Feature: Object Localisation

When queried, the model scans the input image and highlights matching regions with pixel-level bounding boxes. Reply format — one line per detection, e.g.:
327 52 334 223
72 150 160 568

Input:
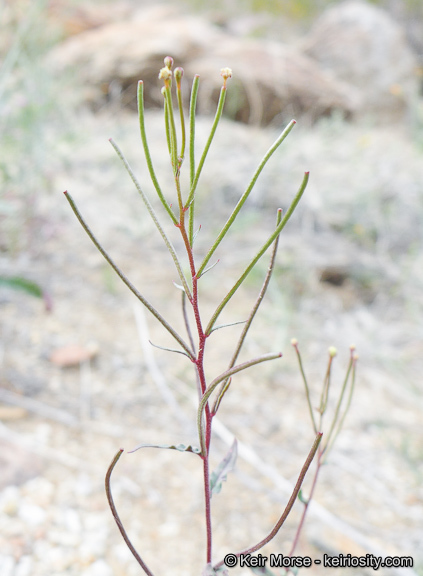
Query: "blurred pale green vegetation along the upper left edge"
0 0 66 254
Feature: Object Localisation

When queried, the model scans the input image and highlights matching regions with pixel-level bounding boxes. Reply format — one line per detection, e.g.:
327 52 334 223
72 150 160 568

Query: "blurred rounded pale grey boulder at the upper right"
303 0 418 120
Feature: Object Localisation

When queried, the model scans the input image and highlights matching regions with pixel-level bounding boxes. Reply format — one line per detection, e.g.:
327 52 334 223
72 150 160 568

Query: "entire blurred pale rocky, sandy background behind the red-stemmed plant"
0 0 423 576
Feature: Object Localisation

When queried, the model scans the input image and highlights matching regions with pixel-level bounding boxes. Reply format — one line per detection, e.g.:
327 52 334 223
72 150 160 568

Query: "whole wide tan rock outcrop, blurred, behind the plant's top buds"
49 5 359 124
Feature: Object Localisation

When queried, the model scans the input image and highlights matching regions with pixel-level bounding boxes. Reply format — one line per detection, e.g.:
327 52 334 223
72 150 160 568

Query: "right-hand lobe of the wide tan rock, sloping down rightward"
186 38 360 125
